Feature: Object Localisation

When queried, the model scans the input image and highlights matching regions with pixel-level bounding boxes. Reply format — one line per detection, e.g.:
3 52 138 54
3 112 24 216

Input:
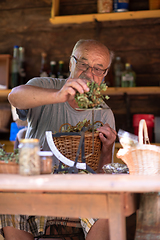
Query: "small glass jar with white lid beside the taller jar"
38 151 53 174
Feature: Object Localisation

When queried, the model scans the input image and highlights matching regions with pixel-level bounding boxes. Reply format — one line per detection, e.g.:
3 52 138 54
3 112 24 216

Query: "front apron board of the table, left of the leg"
0 192 108 218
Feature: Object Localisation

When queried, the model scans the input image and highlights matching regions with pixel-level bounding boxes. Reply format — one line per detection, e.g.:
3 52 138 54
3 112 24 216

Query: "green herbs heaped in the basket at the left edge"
0 144 19 163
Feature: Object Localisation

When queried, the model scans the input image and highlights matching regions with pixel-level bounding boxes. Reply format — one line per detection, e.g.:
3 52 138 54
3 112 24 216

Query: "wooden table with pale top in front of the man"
0 174 160 240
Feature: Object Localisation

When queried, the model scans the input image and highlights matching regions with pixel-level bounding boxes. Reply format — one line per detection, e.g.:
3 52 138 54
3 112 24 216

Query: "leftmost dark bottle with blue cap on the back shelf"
10 45 19 88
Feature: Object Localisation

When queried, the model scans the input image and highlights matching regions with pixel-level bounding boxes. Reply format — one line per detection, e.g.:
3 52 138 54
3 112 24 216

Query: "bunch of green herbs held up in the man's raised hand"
75 82 109 109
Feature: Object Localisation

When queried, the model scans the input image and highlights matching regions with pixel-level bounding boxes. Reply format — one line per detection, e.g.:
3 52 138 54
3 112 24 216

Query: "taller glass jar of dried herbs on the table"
19 138 40 175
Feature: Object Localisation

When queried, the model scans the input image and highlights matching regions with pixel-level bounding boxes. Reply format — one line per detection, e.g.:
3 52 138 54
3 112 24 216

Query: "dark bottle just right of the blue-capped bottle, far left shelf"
19 47 26 85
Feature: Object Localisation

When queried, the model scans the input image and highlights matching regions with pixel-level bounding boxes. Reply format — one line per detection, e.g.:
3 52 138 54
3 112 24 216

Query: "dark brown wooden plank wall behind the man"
0 0 160 137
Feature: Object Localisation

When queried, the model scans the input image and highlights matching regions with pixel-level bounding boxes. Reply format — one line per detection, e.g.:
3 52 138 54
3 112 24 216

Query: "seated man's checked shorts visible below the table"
0 215 97 237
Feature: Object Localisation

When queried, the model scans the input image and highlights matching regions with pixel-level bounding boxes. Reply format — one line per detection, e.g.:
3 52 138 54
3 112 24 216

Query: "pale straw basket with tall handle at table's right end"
117 119 160 175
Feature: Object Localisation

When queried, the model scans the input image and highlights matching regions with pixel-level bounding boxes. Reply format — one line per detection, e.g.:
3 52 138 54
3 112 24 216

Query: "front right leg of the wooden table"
108 193 126 240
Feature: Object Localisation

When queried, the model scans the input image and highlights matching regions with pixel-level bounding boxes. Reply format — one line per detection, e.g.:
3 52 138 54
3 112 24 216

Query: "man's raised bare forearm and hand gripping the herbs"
8 79 89 109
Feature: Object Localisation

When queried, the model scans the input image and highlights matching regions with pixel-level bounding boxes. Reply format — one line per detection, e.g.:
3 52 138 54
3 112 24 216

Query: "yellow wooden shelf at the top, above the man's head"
50 0 160 24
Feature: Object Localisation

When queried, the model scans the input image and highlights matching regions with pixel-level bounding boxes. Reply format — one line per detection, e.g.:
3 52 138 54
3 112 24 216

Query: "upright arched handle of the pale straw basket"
138 119 150 144
